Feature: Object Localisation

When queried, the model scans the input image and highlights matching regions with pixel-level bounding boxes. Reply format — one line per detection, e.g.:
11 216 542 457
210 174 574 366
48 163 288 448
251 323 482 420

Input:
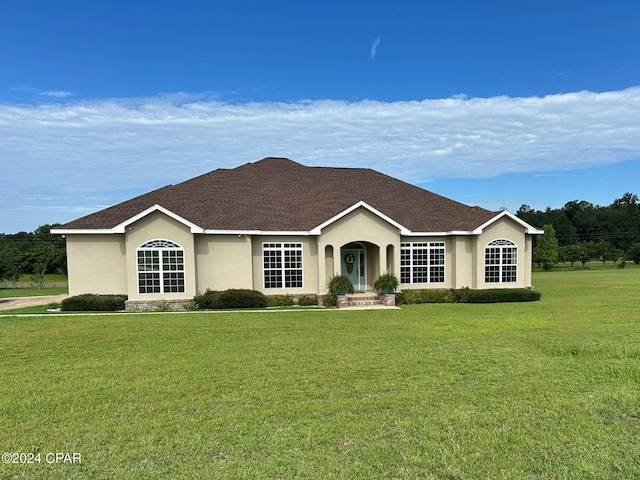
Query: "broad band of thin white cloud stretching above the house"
0 87 640 231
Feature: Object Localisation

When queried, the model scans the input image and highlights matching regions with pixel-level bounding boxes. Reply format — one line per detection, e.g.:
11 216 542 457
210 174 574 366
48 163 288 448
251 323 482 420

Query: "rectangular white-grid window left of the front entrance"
262 243 302 288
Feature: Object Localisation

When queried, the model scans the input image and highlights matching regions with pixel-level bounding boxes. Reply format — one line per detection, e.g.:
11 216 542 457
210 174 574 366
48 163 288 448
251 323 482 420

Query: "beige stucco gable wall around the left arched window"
125 212 197 300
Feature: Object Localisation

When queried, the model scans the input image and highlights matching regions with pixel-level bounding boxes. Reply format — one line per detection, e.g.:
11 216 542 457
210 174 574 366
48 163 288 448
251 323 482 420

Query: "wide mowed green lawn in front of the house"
0 267 640 479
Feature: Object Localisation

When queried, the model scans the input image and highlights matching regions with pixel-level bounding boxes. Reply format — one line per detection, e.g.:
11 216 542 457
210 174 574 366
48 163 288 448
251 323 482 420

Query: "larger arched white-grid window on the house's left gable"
137 240 185 293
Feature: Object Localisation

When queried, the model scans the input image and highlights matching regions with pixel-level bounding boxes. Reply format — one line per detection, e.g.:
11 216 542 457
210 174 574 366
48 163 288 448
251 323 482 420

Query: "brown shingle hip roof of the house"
58 157 497 232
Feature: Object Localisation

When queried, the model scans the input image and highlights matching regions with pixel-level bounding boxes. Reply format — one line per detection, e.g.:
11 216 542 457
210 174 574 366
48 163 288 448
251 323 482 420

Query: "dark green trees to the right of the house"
516 193 640 266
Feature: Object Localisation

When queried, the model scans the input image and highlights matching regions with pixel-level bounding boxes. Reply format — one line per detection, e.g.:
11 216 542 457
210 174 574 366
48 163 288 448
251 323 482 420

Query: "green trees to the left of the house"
0 224 67 286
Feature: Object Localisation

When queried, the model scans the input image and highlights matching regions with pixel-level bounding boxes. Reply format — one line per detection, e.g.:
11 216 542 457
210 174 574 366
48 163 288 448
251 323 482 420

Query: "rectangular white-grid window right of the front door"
400 242 445 283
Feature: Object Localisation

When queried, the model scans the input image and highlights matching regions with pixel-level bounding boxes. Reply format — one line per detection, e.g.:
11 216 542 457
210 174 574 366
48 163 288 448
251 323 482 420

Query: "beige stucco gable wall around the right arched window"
470 217 532 289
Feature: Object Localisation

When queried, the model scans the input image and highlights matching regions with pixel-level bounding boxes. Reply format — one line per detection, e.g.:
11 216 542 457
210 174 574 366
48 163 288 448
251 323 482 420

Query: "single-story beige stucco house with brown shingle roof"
52 158 542 302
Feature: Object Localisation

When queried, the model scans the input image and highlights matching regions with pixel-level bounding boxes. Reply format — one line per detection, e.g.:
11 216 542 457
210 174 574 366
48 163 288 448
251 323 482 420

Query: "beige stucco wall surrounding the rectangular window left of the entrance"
249 235 318 295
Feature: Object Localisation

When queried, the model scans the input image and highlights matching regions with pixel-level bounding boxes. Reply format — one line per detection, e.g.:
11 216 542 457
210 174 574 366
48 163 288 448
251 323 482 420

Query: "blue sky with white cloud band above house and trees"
0 0 640 233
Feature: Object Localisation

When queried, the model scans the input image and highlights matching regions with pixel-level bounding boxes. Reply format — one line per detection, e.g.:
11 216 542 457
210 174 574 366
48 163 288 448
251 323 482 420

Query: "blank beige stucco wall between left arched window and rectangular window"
195 235 254 292
